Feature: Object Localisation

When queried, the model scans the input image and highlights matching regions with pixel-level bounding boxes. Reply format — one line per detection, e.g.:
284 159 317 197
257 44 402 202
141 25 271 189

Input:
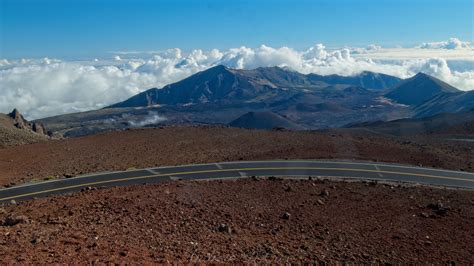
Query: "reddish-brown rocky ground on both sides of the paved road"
0 123 474 264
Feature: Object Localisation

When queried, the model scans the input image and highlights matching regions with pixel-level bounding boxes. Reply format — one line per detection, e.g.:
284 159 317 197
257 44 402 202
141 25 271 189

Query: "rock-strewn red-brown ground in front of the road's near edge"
0 178 474 265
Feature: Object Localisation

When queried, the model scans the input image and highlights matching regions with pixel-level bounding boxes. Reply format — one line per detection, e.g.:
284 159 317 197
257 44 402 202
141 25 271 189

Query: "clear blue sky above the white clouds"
0 0 474 59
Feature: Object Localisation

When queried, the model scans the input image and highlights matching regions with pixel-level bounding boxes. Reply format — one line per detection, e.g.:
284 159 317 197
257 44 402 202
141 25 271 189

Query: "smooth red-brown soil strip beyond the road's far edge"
0 126 474 186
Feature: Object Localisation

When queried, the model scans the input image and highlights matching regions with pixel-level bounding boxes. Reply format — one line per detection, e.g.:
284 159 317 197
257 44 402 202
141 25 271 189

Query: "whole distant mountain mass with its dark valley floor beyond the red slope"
35 65 468 136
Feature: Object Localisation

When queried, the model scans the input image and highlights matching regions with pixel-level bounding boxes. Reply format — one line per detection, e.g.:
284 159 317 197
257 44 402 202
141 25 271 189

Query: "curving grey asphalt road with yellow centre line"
0 160 474 203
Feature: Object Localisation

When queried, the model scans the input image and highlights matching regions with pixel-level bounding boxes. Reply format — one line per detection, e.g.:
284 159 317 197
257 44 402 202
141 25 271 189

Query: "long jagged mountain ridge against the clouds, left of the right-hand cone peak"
106 65 401 108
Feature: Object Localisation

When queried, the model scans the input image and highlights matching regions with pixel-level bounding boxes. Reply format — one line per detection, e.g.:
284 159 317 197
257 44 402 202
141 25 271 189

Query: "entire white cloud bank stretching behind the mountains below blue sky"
0 38 474 119
